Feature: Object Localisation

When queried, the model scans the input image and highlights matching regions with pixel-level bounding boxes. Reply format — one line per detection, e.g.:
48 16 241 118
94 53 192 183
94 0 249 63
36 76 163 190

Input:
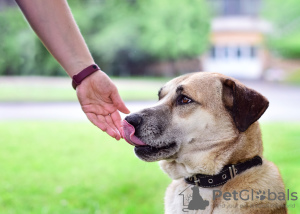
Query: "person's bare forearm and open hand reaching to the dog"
16 0 129 140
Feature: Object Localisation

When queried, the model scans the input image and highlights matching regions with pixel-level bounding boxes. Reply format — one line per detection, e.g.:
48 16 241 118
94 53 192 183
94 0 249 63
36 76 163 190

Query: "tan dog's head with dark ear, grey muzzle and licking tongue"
123 72 268 176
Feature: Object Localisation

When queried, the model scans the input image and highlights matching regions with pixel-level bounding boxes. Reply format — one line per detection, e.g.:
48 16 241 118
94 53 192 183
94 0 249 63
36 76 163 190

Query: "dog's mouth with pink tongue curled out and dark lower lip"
122 120 176 160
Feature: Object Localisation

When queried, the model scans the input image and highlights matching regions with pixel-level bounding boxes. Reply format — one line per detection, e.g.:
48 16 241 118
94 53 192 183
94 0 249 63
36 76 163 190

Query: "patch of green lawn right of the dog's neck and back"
262 123 300 214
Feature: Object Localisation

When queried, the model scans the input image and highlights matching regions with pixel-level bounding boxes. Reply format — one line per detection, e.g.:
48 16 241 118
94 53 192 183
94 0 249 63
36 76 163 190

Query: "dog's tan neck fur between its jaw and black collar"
160 122 263 180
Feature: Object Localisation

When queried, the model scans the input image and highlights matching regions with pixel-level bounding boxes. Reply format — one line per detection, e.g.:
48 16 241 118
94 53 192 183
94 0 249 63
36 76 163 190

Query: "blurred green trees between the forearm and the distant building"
81 0 209 75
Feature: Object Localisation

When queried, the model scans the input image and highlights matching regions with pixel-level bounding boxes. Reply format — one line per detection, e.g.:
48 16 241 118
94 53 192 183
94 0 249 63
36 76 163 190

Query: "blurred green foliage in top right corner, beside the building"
264 0 300 58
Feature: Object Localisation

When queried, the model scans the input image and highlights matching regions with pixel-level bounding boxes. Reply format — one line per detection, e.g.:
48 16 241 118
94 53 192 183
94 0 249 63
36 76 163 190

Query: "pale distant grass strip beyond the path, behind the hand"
0 77 169 102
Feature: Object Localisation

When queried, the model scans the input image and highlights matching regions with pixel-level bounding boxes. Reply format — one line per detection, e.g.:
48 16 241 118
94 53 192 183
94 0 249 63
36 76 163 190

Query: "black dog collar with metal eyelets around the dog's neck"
184 156 262 187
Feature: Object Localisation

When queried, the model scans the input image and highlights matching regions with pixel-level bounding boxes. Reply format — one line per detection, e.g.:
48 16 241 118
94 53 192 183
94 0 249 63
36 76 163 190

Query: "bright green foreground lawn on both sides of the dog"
0 122 300 214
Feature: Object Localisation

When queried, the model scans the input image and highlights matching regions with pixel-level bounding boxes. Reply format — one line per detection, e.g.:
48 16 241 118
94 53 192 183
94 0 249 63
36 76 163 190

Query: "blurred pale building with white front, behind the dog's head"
202 0 270 79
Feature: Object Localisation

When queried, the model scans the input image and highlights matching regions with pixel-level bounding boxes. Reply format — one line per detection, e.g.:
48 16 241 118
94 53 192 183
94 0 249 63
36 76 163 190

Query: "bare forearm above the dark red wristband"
16 0 94 77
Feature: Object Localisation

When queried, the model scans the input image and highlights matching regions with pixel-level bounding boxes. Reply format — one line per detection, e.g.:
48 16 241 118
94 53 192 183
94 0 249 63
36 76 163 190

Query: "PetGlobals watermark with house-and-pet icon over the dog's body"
179 185 298 212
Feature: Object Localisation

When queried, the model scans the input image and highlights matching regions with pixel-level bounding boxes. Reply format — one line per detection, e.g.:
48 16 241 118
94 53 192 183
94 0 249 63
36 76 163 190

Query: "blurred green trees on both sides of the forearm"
0 0 209 75
